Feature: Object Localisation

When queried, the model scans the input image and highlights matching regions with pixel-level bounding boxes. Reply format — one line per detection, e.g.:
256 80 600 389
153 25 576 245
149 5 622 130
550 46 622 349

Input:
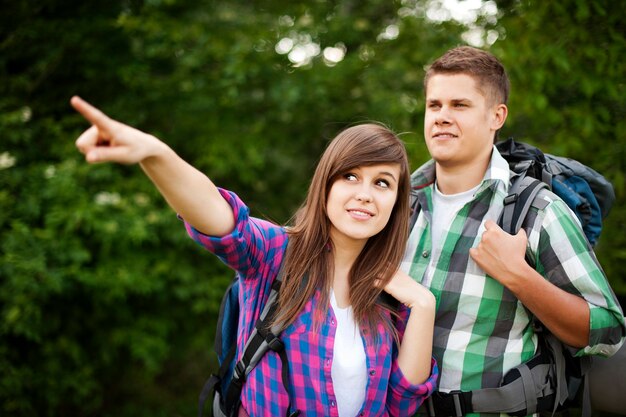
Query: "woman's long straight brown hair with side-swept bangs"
274 124 410 334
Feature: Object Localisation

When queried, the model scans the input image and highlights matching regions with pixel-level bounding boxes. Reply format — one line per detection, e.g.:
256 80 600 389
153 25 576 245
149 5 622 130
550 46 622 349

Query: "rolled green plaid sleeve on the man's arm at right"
529 193 626 356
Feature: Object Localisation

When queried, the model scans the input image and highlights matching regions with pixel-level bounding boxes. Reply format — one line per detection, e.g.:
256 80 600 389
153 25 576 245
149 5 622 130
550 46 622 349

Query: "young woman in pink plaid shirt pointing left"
71 97 437 417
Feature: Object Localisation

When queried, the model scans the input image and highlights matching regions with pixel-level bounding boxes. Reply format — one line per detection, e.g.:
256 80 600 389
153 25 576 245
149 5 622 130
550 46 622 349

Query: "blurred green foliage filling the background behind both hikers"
0 0 626 416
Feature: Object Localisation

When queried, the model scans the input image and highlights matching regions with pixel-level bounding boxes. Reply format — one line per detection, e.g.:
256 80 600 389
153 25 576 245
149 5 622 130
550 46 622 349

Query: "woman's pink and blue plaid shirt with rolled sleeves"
186 189 438 417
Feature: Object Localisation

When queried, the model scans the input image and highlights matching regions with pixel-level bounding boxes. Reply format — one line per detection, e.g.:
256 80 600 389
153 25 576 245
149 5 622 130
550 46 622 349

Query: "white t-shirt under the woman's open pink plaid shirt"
330 291 367 417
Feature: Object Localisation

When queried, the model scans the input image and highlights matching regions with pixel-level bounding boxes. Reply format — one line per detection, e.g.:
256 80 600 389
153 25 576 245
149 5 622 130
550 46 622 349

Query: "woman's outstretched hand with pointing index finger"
70 96 167 164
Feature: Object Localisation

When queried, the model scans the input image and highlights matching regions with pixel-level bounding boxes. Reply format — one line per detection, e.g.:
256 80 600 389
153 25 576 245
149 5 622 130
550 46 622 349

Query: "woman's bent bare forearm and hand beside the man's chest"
385 271 436 384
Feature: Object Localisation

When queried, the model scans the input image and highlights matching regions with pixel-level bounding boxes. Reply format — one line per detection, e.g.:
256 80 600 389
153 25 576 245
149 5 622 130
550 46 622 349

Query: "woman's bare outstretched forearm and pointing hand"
71 96 235 236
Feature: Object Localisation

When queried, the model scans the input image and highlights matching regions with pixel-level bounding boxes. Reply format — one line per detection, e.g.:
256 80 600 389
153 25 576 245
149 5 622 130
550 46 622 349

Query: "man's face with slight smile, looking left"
424 74 506 170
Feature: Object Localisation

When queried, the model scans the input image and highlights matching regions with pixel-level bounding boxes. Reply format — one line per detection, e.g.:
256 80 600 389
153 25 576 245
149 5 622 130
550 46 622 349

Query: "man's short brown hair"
424 46 509 104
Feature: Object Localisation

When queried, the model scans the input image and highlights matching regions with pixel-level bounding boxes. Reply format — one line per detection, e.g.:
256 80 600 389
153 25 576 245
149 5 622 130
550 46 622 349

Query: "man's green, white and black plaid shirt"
402 147 626 412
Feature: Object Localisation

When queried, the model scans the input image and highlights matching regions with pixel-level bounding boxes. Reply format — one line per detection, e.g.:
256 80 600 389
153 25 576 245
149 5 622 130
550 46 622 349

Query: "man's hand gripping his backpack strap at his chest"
469 220 528 288
